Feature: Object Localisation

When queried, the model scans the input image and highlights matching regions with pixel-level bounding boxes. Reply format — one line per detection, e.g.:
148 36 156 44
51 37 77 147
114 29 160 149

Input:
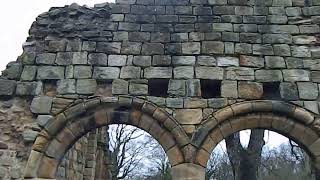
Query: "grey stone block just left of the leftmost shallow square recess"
16 82 42 96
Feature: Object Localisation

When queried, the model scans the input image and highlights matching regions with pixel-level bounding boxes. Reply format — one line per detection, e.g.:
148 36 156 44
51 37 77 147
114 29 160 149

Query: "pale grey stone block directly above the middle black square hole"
195 67 224 80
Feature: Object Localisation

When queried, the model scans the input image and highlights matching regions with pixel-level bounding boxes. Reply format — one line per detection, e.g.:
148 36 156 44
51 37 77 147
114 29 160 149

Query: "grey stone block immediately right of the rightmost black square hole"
279 82 299 101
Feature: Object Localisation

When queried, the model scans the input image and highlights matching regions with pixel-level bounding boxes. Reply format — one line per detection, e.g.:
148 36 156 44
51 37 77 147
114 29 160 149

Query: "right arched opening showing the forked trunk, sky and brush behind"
206 129 316 180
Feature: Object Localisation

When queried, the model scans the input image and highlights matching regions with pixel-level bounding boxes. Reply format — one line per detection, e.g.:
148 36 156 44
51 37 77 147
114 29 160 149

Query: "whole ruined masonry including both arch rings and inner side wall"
0 0 320 180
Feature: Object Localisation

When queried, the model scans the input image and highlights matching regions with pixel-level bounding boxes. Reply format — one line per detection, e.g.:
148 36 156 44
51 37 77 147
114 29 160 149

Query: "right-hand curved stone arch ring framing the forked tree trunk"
192 101 320 171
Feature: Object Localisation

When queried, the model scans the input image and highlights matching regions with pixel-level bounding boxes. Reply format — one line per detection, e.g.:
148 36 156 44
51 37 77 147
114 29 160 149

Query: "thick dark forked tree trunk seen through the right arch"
226 129 265 180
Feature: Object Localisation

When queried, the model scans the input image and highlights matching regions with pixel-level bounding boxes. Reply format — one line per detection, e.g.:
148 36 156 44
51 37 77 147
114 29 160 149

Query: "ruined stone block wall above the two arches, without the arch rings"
0 0 320 177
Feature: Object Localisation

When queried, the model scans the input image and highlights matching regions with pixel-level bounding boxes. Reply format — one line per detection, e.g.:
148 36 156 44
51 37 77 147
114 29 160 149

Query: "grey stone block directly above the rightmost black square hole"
255 70 283 82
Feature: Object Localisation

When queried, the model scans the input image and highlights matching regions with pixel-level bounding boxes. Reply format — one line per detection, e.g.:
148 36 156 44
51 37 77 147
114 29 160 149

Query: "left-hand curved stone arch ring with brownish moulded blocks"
25 97 189 179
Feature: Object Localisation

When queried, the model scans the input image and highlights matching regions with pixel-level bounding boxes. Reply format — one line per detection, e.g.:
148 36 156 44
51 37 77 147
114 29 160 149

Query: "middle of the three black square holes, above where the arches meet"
200 80 221 99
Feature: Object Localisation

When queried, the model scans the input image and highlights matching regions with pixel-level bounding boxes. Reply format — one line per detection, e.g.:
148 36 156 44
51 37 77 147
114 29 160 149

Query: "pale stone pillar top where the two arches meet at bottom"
172 163 206 180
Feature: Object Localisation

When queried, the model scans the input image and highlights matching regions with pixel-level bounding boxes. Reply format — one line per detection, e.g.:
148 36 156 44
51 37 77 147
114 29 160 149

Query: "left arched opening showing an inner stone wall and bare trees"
57 124 171 180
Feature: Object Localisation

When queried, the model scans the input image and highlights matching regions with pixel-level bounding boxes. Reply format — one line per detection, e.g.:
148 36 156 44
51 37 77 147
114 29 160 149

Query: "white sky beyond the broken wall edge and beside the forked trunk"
0 0 285 146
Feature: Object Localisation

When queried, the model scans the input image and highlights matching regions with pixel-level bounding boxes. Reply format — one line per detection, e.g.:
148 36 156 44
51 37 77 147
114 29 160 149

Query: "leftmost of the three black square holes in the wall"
149 79 169 97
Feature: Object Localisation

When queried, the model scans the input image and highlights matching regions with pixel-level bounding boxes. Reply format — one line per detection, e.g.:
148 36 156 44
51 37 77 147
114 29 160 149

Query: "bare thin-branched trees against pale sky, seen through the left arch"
109 125 171 180
